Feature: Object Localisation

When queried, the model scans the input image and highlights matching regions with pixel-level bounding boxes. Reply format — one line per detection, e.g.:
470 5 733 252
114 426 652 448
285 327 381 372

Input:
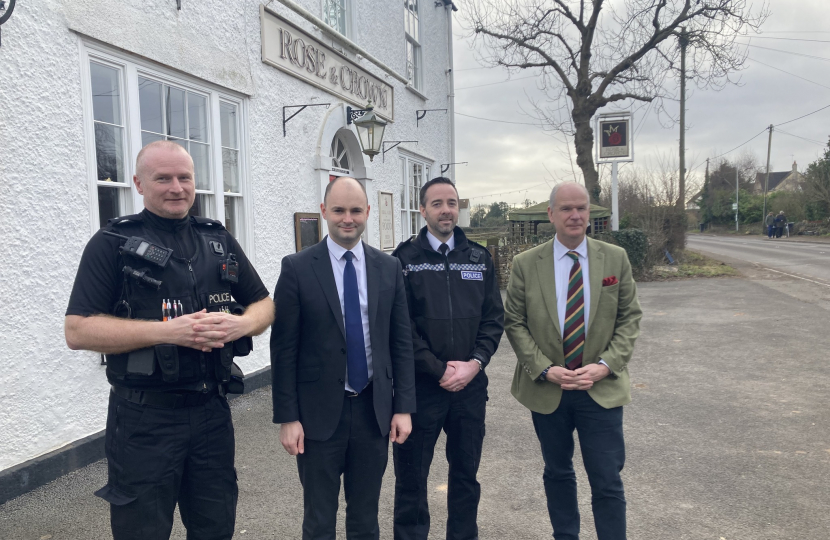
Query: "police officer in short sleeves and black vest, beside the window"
65 141 274 540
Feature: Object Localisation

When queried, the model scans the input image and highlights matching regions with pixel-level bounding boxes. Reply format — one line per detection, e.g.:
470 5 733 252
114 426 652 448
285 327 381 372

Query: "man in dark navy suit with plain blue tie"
271 177 415 540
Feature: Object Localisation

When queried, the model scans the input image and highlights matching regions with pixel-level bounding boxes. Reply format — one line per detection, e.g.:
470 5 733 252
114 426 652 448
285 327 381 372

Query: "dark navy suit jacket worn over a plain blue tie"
271 238 415 441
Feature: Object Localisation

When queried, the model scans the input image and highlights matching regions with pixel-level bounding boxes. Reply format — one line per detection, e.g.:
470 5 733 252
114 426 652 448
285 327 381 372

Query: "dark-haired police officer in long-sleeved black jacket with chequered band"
393 177 504 540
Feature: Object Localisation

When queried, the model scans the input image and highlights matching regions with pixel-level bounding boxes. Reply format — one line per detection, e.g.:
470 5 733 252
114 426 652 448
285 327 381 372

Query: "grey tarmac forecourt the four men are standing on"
0 273 830 540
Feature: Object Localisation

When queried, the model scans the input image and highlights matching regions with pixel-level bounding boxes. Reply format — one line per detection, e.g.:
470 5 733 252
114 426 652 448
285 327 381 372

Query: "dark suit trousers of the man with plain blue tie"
298 385 389 540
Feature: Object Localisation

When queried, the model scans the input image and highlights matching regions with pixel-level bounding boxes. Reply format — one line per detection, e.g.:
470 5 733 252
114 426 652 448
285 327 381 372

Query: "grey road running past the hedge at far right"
688 234 830 286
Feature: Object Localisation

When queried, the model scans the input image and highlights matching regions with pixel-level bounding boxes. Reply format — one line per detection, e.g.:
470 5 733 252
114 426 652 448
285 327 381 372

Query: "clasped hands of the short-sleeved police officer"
163 309 248 352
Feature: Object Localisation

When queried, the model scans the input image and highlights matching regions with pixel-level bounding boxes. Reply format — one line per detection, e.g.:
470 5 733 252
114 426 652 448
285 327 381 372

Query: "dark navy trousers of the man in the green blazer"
532 390 625 540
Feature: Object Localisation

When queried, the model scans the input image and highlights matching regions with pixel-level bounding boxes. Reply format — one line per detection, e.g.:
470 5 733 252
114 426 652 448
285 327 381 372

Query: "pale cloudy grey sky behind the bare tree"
453 0 830 208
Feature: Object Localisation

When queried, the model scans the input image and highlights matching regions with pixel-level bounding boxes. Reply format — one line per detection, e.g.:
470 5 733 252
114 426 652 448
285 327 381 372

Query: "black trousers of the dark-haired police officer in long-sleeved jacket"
393 371 487 540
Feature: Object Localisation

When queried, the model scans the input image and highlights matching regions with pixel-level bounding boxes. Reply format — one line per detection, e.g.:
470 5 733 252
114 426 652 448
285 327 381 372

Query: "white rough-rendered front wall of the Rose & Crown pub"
0 0 450 470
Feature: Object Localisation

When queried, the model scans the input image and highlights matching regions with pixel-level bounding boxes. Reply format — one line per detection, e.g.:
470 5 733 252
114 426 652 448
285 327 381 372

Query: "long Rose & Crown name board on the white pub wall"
259 6 395 122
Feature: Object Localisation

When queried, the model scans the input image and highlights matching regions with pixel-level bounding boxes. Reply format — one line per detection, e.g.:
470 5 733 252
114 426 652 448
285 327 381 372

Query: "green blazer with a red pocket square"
504 238 643 414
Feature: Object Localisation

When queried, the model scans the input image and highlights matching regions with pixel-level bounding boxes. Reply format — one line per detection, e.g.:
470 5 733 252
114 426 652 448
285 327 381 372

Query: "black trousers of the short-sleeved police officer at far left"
95 393 238 540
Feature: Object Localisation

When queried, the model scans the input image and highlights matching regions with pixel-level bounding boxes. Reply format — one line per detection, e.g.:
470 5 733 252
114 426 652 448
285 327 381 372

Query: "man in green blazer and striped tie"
504 183 642 540
